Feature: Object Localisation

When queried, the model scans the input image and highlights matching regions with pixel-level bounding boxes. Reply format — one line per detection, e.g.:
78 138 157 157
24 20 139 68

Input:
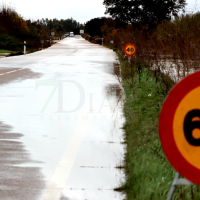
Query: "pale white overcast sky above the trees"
0 0 200 23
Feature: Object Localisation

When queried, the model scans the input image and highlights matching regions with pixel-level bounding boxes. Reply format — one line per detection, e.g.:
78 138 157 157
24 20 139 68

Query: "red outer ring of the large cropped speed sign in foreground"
159 71 200 185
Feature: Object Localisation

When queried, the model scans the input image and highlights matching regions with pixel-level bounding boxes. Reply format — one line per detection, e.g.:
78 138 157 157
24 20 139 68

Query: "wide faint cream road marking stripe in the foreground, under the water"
41 120 88 200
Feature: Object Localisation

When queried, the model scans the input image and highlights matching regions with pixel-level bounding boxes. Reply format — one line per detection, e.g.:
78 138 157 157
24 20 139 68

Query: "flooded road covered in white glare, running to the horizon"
0 36 124 200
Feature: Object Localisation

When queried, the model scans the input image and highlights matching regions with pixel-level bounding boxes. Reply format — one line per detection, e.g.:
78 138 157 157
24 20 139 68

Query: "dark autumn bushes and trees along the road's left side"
0 3 84 52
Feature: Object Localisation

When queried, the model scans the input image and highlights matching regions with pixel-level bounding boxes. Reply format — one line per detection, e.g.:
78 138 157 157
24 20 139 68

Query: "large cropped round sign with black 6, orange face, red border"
159 72 200 185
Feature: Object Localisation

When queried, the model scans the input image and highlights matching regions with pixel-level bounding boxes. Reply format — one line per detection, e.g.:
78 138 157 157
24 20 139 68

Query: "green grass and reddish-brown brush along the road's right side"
83 1 200 200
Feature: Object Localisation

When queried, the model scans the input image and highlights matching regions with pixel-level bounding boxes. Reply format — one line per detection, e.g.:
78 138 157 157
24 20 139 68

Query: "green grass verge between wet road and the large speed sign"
116 51 200 200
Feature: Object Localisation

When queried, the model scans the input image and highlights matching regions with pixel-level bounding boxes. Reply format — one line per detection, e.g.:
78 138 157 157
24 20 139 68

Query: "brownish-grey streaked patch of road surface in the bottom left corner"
0 122 45 200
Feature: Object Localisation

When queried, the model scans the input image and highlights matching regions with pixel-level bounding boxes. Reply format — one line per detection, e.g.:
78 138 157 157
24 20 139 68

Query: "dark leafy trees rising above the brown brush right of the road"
85 0 186 37
